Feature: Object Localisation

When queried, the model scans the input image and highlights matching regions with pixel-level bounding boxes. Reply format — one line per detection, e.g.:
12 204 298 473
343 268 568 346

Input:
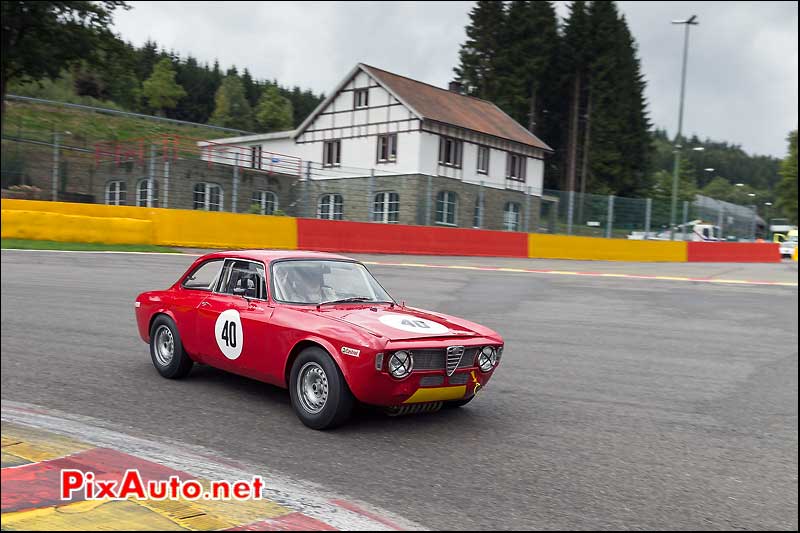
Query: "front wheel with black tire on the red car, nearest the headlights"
289 346 355 429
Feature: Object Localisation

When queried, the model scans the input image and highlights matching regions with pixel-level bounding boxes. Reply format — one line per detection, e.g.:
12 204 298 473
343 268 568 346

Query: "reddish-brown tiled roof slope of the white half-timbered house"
362 65 552 151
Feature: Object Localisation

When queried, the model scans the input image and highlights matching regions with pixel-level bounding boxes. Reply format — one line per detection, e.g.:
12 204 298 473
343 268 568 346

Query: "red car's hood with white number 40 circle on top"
315 306 493 340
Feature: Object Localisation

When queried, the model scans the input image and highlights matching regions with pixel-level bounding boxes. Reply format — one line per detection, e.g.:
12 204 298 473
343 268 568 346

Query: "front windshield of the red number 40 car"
272 260 394 304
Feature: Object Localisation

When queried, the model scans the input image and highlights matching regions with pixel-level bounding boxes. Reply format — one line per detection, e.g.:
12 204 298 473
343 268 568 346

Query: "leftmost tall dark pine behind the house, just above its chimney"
454 0 506 101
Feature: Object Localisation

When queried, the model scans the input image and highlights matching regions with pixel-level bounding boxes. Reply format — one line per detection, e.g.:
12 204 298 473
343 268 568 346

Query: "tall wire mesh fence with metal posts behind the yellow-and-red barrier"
0 135 766 241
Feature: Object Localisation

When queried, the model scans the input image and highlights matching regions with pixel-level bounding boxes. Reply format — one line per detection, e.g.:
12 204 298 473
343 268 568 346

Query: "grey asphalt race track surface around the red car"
0 251 798 529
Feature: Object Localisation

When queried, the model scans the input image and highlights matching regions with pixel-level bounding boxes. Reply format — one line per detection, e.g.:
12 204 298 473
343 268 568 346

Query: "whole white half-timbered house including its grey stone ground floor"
200 63 552 230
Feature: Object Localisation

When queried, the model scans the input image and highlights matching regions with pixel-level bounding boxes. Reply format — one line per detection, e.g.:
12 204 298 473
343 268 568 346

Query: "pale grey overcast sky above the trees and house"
115 1 798 157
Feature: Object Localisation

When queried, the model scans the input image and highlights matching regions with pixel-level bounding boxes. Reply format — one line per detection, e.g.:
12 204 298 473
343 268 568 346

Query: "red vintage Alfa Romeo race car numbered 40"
135 250 503 429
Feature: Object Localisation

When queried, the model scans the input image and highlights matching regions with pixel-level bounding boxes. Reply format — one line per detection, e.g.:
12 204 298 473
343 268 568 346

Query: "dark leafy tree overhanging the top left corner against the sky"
0 1 127 116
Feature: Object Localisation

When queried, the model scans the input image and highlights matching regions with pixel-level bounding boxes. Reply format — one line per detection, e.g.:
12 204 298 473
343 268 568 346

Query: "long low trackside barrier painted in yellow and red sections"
2 199 781 262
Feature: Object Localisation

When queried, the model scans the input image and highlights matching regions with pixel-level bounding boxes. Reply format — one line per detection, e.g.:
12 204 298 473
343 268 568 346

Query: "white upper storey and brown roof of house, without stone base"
201 63 552 189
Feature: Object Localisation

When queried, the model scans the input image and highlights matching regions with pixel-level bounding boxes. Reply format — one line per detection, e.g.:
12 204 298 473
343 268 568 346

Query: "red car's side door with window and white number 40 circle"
195 259 273 379
